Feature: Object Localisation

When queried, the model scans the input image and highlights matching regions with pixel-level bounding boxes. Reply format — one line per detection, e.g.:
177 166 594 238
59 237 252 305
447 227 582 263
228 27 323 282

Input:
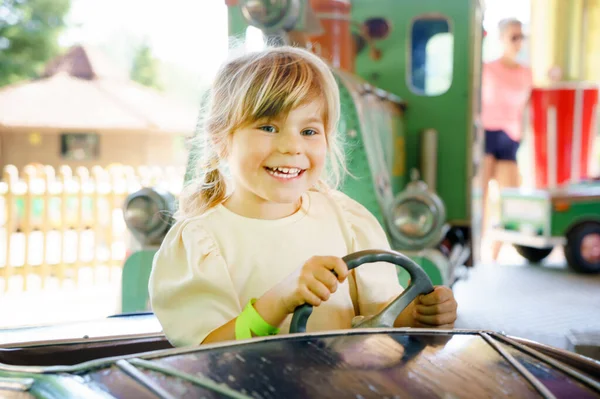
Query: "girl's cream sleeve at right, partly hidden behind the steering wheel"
333 192 404 316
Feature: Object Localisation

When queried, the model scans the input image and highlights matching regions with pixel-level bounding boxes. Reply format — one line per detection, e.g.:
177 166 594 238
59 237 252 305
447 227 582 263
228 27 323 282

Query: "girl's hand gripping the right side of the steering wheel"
412 286 458 329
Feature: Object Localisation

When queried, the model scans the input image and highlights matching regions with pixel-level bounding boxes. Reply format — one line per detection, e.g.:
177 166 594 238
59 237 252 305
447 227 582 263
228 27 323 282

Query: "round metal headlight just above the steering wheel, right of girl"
388 180 448 249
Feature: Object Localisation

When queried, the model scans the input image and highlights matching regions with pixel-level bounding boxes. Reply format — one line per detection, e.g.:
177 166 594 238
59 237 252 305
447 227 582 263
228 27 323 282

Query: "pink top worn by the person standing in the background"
481 60 533 141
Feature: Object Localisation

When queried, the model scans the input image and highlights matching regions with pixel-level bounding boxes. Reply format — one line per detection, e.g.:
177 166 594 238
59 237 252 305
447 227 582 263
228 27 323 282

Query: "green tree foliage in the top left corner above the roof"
0 0 71 87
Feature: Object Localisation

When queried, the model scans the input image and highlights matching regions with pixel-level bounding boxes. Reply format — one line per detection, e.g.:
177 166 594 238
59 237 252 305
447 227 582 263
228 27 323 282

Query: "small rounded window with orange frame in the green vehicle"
407 16 454 96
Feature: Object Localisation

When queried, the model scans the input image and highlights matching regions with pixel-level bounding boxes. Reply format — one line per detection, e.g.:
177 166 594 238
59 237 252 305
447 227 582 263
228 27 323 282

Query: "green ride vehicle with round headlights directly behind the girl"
123 0 482 311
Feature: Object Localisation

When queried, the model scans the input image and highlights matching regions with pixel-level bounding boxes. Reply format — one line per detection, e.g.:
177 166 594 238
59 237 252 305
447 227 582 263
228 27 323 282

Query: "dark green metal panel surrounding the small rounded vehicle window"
352 0 481 225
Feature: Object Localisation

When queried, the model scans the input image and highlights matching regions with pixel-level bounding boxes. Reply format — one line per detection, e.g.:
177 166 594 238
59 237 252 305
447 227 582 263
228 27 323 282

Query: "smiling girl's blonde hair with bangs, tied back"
175 46 345 219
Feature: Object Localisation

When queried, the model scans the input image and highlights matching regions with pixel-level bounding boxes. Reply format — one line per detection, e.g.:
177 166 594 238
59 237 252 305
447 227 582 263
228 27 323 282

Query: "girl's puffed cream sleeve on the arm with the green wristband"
148 220 241 346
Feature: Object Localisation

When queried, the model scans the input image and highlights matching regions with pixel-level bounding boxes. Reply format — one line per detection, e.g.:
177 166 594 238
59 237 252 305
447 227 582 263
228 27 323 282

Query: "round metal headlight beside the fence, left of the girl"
123 188 175 245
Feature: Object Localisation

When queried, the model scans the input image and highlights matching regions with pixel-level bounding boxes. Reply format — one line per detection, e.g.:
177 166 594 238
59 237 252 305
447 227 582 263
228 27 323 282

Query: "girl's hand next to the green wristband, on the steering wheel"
277 256 348 314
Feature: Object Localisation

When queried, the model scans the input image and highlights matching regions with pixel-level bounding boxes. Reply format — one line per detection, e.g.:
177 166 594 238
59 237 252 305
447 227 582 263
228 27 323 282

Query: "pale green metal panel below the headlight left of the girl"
121 252 157 313
